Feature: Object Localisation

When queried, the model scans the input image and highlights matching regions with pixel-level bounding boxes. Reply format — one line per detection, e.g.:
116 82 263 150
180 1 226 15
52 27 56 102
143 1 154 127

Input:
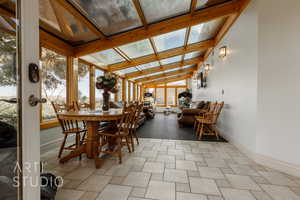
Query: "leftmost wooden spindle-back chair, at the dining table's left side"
51 102 87 159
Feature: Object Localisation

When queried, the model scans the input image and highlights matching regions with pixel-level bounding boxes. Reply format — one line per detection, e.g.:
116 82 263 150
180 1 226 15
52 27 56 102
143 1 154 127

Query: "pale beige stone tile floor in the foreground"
41 139 300 200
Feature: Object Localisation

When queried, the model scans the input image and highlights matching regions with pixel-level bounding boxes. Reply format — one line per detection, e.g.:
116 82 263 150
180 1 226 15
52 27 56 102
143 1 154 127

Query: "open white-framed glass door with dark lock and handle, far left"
0 0 40 200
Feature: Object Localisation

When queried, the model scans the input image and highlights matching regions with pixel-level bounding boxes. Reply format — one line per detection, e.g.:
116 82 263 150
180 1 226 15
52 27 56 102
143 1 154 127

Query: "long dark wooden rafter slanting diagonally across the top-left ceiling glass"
55 0 106 40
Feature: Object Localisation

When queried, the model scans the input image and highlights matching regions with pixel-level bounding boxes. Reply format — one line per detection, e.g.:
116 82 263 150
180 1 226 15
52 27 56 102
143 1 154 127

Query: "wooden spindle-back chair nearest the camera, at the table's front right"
98 105 135 164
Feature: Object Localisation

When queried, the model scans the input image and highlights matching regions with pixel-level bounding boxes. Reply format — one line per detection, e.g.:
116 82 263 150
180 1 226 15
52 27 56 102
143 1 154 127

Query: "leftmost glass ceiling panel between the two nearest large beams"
82 49 125 66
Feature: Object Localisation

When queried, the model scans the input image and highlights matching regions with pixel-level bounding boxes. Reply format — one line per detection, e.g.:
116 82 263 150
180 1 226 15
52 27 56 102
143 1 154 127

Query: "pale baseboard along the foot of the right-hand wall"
222 135 300 177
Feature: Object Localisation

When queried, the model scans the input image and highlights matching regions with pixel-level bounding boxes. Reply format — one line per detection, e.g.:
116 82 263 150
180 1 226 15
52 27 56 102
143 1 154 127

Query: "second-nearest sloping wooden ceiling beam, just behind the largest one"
107 40 214 71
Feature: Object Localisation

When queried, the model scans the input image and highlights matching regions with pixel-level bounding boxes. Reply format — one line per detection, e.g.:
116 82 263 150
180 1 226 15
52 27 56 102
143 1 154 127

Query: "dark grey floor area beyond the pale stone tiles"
137 113 226 142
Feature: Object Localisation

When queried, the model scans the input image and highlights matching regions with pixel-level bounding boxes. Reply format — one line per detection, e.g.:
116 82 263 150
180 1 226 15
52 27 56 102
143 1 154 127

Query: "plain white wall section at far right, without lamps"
257 0 300 165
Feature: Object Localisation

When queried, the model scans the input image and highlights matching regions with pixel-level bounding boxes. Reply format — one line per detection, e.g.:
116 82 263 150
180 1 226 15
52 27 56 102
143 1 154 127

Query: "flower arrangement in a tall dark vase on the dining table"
96 72 118 111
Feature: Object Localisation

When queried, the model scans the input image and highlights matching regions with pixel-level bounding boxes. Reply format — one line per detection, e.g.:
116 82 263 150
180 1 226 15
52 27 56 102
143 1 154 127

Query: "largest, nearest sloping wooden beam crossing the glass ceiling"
74 0 241 57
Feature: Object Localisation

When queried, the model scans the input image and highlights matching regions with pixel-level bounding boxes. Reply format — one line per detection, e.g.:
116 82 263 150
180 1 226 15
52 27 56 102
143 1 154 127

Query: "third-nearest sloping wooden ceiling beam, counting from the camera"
125 58 203 79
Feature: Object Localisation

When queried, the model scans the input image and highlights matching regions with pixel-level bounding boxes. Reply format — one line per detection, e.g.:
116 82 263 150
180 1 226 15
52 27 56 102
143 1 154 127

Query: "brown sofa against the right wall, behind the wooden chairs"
177 101 210 126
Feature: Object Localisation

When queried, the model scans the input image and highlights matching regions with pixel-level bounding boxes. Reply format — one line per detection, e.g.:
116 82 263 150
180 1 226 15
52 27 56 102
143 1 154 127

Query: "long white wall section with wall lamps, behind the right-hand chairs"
193 0 257 151
